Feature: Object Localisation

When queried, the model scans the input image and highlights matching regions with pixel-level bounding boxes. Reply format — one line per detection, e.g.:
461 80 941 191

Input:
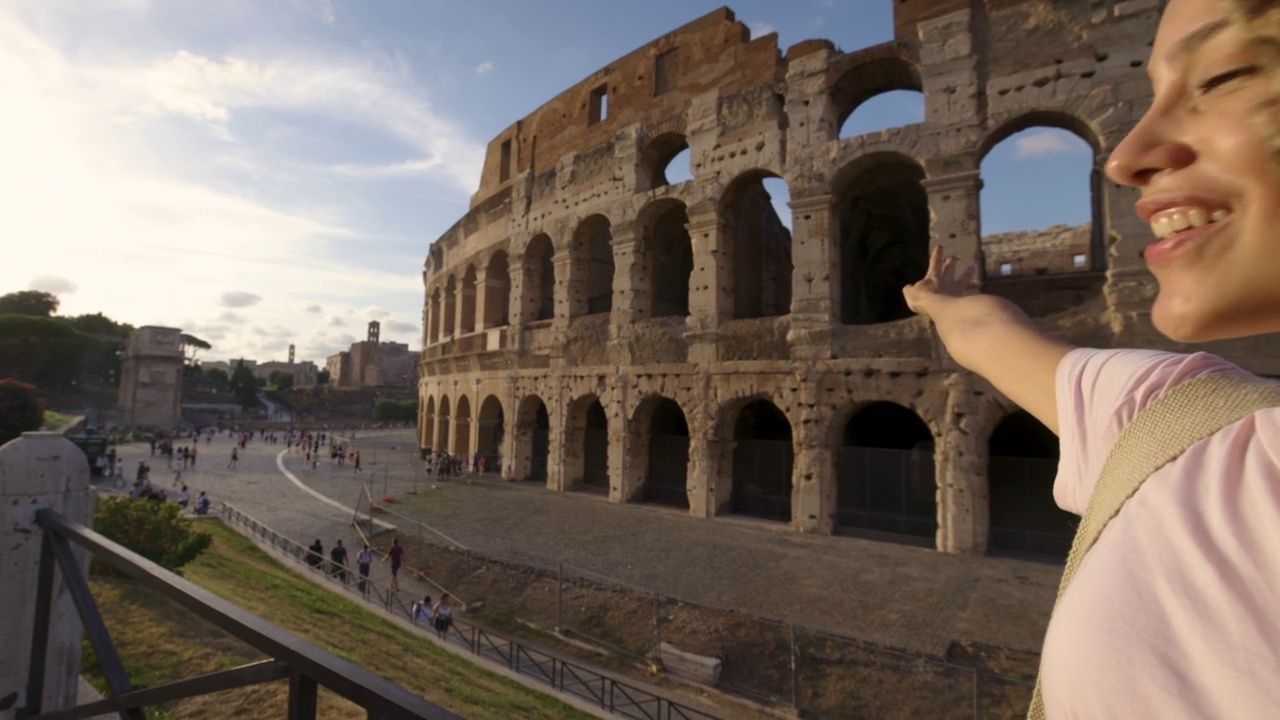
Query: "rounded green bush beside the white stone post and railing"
93 497 214 570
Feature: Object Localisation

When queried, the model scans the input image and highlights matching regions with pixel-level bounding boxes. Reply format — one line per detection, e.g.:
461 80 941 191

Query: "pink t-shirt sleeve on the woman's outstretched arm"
1053 348 1235 515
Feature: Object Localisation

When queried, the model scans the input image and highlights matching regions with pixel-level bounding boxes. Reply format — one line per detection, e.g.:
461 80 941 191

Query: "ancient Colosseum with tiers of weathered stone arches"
419 0 1280 555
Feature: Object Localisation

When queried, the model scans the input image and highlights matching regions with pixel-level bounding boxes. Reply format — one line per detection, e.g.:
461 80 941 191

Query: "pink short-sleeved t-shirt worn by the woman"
1041 350 1280 720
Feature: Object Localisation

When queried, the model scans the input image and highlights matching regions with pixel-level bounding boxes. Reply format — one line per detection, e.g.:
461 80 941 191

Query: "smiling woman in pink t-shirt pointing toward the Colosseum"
904 0 1280 719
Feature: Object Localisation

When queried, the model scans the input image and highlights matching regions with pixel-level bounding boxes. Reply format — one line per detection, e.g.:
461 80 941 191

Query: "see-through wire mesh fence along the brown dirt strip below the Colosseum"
360 495 1033 719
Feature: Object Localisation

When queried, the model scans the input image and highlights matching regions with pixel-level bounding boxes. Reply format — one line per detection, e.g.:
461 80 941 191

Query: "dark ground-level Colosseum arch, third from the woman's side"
721 397 795 523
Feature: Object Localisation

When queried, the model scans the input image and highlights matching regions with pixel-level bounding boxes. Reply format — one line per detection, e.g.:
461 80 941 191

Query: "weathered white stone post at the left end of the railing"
0 433 93 720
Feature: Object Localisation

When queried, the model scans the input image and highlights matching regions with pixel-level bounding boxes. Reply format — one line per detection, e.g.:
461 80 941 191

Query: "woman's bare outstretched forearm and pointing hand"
902 247 1074 433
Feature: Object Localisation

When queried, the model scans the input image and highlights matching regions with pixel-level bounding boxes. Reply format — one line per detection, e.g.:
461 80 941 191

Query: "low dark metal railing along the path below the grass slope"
221 499 716 720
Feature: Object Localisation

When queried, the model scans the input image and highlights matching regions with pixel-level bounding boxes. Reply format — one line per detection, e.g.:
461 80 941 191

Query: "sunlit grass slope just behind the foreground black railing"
84 521 590 720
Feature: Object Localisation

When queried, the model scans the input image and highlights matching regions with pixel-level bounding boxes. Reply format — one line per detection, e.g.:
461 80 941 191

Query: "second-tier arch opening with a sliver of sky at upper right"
718 170 794 318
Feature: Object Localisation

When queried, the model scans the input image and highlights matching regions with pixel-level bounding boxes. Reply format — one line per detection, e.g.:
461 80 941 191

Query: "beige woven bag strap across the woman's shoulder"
1027 372 1280 720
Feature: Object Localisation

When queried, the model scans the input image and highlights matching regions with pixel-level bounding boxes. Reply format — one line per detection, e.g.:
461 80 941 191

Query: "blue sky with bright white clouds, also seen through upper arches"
0 0 1092 365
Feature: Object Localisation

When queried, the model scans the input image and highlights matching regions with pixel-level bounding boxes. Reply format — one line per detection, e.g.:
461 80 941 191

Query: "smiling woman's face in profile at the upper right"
1107 0 1280 342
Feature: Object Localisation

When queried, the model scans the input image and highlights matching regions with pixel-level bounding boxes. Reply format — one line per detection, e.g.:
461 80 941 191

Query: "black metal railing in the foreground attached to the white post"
18 509 460 720
